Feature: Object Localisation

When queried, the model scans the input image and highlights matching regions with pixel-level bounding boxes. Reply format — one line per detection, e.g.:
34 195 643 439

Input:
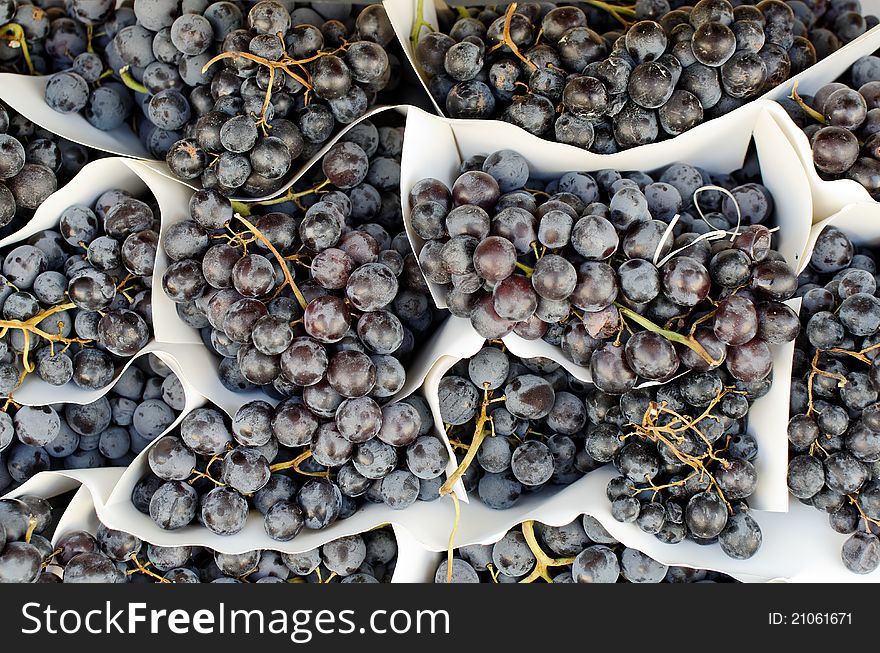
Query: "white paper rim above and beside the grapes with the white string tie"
400 101 813 307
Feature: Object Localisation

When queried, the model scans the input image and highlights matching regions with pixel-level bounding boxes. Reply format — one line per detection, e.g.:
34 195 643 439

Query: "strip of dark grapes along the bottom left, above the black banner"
0 495 397 583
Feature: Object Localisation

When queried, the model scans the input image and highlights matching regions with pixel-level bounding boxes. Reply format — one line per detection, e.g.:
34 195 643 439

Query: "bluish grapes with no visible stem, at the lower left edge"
0 354 186 492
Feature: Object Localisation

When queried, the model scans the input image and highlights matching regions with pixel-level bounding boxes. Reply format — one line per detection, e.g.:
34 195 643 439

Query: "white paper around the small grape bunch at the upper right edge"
772 28 880 222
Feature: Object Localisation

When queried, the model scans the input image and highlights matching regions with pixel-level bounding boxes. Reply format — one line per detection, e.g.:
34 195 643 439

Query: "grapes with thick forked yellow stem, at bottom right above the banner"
434 515 737 583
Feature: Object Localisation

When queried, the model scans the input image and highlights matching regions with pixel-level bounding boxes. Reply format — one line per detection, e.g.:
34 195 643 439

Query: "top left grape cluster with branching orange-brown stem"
38 0 400 196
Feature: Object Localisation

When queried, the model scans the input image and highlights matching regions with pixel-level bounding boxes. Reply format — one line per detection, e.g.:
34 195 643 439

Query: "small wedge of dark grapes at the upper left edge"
0 100 92 235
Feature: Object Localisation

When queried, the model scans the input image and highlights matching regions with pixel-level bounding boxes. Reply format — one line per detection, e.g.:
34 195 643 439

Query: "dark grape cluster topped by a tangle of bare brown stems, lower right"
600 368 771 560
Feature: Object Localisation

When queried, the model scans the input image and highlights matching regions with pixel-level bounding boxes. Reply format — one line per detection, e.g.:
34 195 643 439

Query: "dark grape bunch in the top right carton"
413 0 877 154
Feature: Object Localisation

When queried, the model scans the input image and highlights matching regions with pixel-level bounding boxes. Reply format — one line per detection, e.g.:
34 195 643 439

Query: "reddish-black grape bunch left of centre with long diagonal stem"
162 122 442 402
